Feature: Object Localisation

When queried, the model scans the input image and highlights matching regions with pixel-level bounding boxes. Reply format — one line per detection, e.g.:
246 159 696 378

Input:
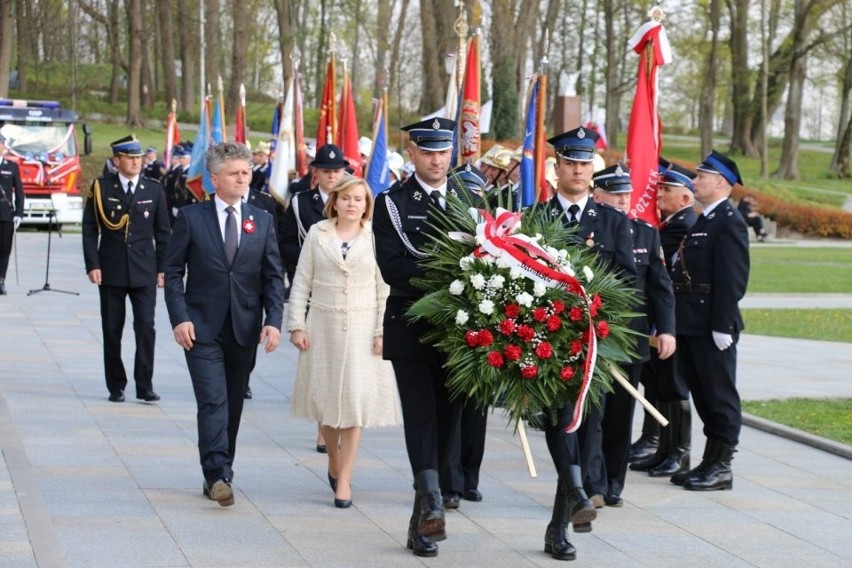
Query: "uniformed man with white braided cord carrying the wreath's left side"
373 118 478 556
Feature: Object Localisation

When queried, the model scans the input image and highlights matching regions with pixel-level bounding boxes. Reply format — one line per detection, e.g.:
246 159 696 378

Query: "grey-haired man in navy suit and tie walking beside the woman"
166 142 284 507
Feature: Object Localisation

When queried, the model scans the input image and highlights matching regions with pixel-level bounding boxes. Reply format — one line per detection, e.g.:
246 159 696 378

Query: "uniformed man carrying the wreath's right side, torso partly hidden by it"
542 127 636 560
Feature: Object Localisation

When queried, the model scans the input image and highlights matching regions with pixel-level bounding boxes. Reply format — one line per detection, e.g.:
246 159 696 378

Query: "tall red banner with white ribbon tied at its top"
627 20 671 226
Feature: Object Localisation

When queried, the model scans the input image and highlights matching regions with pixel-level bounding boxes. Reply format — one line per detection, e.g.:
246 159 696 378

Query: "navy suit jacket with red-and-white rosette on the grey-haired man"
165 199 284 346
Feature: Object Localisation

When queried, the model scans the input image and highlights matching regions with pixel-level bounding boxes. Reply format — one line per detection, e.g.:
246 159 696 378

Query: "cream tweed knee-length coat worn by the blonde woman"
287 220 402 428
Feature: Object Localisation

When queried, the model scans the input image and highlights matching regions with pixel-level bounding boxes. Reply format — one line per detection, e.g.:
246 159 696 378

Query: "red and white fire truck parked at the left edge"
0 99 92 227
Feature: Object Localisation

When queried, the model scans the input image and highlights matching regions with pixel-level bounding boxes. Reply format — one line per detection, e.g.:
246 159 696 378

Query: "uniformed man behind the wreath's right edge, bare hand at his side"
587 165 675 507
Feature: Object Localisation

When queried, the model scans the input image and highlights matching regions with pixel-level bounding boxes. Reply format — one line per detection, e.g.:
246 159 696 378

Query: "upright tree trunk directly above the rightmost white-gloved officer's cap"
727 0 757 156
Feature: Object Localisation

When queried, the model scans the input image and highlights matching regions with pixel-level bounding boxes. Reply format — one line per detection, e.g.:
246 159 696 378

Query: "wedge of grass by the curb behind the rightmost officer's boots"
742 398 852 444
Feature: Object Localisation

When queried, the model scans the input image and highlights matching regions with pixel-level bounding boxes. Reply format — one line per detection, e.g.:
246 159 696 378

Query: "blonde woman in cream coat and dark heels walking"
287 177 402 508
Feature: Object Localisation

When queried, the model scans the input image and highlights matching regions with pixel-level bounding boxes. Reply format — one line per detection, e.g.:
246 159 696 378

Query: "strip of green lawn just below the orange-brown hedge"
748 245 852 294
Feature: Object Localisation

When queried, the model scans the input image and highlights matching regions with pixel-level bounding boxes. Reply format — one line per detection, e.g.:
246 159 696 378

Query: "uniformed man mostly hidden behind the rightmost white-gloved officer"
630 162 697 477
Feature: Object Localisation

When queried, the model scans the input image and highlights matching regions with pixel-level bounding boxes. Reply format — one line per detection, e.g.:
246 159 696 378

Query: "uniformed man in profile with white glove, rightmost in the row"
671 150 750 491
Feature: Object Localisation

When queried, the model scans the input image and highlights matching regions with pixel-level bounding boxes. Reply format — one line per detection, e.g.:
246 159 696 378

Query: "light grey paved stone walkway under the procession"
0 232 852 568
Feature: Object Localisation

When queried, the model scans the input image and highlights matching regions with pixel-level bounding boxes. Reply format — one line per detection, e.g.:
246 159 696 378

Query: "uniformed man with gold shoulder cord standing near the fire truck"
83 135 170 402
